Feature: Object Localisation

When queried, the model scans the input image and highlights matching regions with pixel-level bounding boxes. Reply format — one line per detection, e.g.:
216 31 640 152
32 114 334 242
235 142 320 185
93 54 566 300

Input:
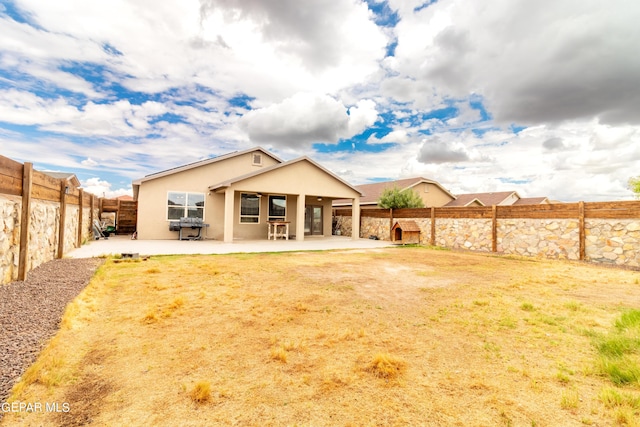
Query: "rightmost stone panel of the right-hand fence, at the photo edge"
585 219 640 267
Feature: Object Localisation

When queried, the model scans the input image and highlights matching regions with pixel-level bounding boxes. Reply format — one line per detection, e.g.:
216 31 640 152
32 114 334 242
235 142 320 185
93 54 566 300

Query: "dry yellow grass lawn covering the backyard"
2 248 640 426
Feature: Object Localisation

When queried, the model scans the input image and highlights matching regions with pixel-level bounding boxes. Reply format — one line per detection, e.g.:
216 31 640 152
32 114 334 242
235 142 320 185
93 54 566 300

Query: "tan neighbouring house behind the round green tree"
333 177 455 209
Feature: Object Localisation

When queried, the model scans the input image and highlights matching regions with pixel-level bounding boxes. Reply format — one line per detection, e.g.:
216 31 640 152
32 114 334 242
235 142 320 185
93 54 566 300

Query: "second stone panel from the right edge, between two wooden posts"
497 219 580 260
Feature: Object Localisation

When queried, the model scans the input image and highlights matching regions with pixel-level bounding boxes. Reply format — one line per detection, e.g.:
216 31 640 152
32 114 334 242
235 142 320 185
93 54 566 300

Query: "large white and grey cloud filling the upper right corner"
383 0 640 124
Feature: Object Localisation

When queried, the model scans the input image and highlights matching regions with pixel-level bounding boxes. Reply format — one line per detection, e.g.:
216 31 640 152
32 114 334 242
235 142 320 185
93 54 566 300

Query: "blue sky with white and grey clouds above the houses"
0 0 640 202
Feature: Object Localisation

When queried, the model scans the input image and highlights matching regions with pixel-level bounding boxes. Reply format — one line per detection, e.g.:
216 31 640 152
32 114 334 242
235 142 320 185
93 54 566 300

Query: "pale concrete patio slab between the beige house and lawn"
65 236 391 258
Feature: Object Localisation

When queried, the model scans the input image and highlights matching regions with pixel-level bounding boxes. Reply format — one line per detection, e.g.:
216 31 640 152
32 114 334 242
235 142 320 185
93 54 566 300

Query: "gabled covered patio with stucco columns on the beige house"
208 157 362 243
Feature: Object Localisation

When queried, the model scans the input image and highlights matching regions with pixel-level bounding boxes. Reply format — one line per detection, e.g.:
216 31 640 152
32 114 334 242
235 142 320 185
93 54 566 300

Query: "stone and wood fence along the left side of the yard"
0 156 100 285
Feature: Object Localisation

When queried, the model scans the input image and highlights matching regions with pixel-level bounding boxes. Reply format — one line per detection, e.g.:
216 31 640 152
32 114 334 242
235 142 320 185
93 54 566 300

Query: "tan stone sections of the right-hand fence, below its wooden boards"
338 216 640 268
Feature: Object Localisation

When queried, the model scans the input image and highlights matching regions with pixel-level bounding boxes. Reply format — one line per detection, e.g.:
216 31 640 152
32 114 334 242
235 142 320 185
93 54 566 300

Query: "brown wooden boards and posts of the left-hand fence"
0 156 137 283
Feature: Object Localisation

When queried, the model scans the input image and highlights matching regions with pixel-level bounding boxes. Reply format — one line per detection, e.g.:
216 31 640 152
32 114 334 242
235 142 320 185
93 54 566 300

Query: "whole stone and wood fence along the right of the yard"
334 201 640 268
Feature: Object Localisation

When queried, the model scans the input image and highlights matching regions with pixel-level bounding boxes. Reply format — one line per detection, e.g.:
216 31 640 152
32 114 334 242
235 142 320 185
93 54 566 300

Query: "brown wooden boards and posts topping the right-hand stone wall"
333 201 640 260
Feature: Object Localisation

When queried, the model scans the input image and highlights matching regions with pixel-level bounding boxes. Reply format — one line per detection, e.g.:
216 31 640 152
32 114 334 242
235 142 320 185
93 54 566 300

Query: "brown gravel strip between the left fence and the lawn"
0 258 104 419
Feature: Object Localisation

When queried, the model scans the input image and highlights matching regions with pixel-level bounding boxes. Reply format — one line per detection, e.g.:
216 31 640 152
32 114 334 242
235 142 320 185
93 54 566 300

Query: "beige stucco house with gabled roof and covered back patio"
133 147 362 242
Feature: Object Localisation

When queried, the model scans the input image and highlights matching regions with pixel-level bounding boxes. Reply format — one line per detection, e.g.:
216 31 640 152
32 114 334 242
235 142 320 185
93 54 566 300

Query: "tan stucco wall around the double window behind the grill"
137 153 277 239
